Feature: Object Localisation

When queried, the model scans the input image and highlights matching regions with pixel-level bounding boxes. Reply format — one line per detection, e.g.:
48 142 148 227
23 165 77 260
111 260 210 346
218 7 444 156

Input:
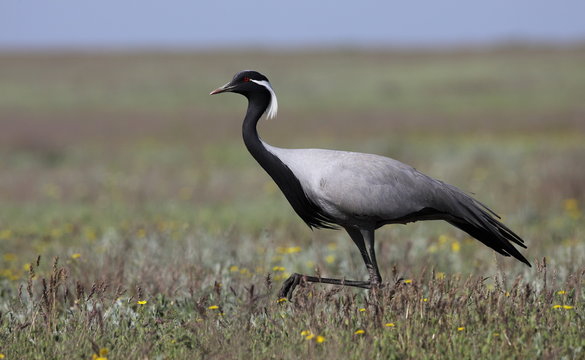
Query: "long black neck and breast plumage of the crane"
242 91 336 229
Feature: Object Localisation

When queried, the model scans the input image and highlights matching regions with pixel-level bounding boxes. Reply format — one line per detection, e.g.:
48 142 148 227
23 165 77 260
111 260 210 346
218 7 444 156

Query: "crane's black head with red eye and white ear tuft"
210 70 278 119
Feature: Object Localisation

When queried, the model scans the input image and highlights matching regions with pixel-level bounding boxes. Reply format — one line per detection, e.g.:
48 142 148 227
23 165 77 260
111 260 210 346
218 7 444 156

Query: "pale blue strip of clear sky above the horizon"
0 0 585 49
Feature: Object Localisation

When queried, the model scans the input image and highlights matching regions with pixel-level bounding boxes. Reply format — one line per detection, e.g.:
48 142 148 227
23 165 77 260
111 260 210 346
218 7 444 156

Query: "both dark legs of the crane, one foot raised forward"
278 228 382 299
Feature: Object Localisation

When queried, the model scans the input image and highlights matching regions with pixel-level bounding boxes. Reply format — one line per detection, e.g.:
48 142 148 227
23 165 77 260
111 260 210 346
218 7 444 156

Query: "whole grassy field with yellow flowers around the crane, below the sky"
0 47 585 359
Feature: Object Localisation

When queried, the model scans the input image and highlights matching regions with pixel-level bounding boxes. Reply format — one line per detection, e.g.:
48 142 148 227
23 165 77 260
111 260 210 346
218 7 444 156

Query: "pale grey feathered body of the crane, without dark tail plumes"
265 144 481 228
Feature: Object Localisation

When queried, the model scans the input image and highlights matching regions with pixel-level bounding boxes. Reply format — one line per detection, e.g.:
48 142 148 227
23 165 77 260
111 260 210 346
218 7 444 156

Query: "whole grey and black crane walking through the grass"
211 70 530 298
